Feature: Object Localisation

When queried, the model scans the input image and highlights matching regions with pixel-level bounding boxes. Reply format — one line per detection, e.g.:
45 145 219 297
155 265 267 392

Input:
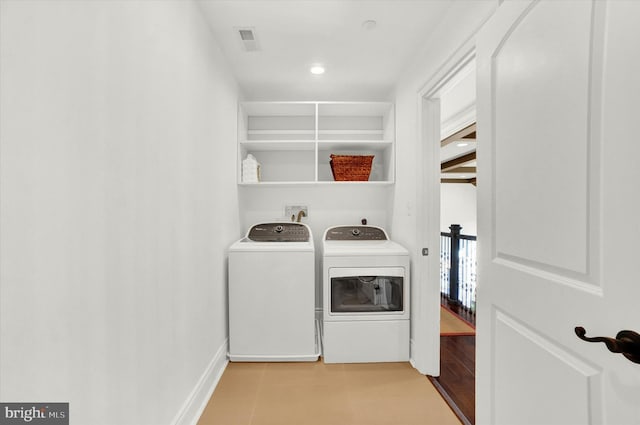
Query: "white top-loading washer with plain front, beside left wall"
229 223 320 362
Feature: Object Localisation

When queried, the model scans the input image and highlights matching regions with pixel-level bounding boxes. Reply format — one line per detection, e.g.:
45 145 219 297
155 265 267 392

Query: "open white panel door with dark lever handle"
476 0 640 425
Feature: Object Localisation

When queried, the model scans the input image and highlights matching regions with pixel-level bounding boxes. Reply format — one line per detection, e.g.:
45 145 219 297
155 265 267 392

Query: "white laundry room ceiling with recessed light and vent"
198 0 454 100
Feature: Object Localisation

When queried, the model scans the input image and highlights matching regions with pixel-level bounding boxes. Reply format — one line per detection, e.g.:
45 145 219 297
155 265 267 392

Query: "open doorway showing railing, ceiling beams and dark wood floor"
422 49 477 424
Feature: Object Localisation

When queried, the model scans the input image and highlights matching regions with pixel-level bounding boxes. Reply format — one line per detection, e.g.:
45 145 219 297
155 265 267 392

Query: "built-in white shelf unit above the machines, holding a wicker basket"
237 102 395 186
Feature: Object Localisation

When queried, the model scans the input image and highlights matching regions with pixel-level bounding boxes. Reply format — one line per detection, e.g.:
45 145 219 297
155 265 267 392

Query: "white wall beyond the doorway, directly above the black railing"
440 183 477 236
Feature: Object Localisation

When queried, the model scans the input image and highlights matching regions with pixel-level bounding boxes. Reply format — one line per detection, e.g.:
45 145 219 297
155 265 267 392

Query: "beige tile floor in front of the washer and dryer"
198 361 460 425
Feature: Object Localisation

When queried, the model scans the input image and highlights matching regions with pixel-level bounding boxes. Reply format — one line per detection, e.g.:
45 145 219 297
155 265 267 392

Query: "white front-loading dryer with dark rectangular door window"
322 225 410 363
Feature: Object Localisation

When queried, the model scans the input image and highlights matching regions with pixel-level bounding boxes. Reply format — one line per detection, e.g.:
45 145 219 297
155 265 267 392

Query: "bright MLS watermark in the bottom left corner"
0 403 69 425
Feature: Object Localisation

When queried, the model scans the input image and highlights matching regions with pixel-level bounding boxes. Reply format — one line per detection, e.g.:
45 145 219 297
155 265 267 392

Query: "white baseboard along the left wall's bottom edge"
172 339 229 425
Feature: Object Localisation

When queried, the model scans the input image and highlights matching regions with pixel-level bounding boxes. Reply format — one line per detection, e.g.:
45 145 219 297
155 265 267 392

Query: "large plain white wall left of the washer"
0 0 240 425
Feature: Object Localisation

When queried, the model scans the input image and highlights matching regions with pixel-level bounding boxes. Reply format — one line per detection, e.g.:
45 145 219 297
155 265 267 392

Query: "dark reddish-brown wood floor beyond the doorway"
430 303 476 424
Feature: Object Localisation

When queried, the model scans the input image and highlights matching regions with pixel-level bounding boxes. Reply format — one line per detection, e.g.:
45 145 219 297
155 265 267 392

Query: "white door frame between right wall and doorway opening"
412 42 484 376
